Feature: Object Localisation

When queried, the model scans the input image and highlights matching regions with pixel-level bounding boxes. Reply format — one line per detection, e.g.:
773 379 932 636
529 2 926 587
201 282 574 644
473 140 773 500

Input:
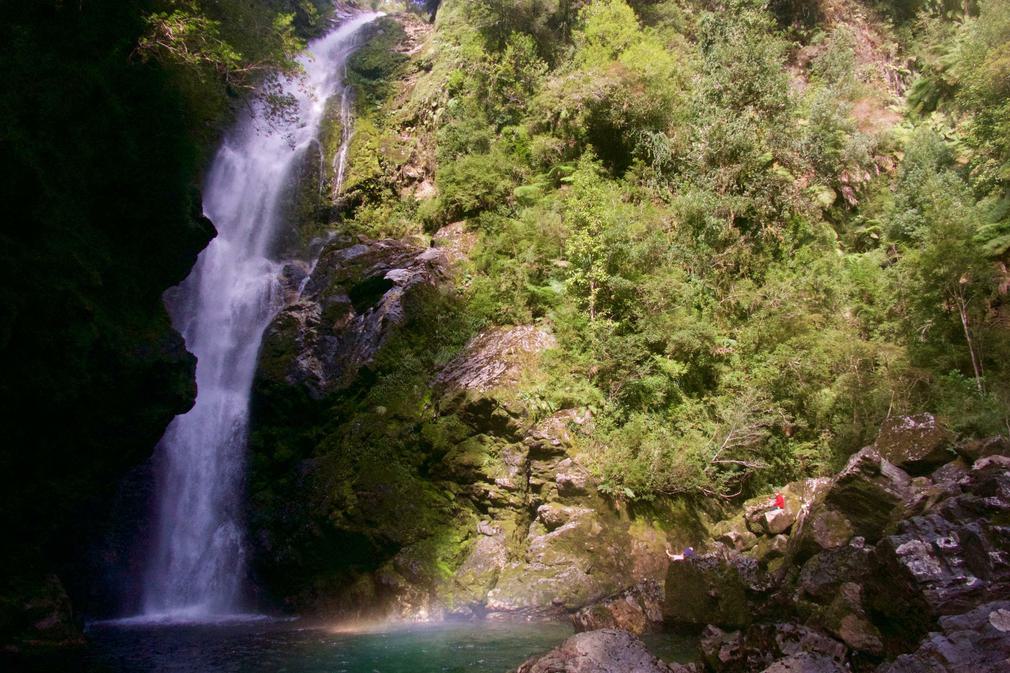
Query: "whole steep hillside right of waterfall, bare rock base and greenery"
238 0 1007 618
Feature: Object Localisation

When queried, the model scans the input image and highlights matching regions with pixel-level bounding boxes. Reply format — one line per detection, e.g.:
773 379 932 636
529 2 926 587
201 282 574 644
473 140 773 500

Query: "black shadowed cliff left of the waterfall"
0 2 213 653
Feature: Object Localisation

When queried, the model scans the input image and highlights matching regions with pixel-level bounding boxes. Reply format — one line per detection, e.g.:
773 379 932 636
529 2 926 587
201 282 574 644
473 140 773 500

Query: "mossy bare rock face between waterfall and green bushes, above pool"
249 234 668 618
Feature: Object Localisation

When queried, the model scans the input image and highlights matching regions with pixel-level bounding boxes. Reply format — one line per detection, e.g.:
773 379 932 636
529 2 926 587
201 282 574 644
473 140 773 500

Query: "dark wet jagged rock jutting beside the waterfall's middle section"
258 235 446 397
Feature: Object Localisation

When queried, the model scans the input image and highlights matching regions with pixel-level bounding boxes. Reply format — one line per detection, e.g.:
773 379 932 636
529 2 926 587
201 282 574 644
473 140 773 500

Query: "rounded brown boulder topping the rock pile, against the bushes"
874 413 956 475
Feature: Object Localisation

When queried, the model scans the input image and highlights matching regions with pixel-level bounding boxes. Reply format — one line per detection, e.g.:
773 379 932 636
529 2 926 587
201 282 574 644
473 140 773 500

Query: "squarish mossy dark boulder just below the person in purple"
663 553 773 628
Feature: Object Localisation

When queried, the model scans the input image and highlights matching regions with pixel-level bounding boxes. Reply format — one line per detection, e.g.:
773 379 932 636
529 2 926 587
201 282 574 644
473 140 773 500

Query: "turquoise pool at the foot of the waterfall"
74 622 693 673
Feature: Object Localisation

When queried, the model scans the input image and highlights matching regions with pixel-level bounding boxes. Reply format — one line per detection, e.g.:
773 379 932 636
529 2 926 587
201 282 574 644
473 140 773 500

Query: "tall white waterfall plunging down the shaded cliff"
143 13 381 620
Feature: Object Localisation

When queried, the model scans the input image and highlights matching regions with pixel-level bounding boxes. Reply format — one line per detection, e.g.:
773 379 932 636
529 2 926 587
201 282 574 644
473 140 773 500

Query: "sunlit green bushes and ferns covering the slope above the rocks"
335 0 1010 499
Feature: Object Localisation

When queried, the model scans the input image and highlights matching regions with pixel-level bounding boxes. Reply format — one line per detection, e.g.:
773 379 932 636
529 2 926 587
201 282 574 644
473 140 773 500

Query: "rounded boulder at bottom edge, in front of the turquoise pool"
516 629 692 673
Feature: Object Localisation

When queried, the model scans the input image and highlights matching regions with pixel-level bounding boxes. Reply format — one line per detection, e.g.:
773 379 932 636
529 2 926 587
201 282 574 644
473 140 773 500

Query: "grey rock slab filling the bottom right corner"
878 601 1010 673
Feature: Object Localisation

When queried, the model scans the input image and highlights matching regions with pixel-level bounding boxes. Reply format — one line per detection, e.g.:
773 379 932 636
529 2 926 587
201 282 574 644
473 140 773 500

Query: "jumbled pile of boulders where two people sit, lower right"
665 414 1010 673
